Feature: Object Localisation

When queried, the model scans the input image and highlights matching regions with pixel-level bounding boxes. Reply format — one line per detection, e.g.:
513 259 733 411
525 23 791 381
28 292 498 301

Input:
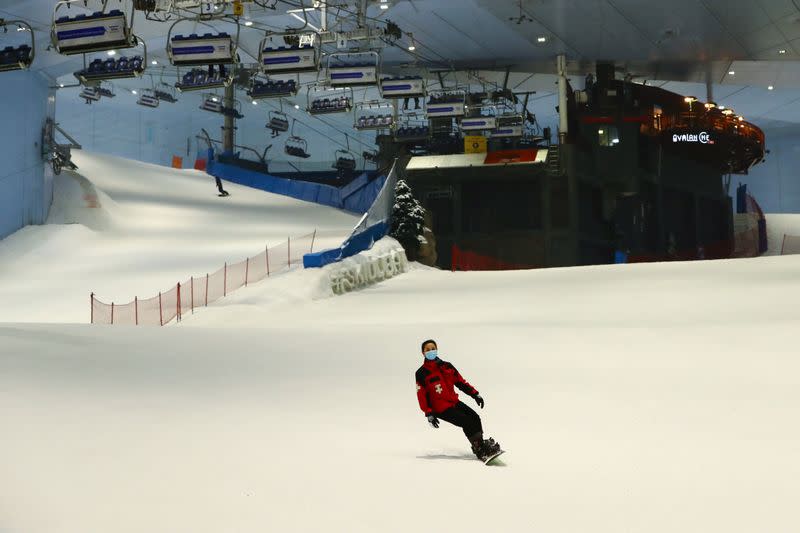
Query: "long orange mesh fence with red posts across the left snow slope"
91 230 317 326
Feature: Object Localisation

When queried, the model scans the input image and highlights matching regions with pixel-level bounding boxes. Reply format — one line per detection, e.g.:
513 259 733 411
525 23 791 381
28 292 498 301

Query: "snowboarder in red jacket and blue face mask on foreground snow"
416 339 501 461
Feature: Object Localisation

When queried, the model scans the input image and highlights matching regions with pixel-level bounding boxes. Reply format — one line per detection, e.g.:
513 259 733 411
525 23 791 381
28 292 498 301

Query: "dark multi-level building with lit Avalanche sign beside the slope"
404 65 764 268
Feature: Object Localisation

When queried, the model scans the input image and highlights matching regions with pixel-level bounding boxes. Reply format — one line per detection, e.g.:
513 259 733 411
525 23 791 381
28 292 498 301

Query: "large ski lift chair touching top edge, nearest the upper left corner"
50 0 138 55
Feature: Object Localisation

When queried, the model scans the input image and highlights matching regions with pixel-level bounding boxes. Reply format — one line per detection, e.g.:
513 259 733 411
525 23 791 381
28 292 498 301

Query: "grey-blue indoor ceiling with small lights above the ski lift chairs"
0 0 800 129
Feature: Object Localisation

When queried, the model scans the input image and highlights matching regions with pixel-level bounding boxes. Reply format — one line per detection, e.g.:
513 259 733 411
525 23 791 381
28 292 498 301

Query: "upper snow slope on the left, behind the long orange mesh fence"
0 151 358 323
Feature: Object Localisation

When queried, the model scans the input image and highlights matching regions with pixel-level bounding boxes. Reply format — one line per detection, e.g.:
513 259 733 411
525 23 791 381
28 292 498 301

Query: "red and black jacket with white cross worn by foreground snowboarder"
416 359 478 415
